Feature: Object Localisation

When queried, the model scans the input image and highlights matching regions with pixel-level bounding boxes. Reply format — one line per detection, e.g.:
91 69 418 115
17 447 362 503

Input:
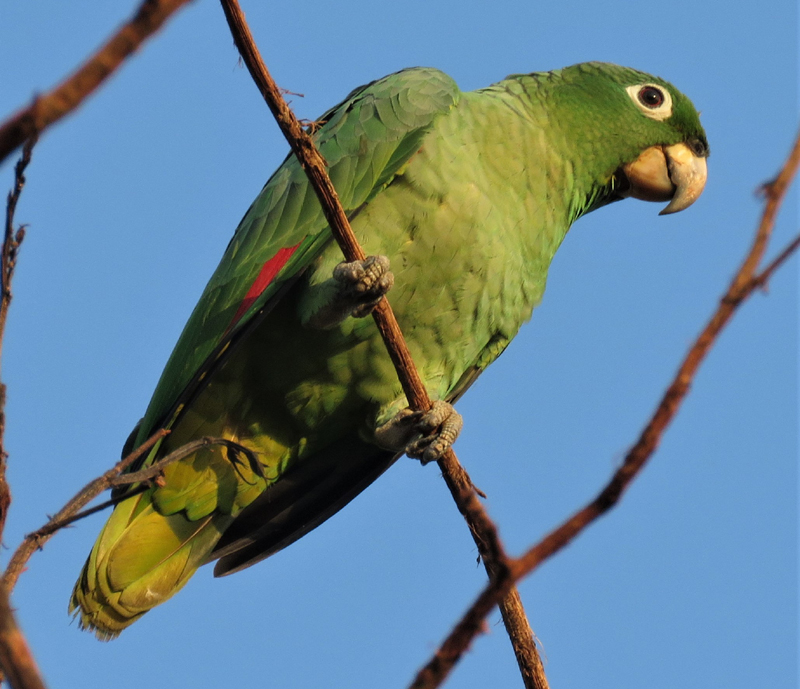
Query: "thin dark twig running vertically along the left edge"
0 137 36 542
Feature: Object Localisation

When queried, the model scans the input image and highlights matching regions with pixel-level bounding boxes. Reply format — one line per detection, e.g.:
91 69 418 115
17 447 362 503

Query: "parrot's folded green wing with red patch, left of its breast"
135 67 460 445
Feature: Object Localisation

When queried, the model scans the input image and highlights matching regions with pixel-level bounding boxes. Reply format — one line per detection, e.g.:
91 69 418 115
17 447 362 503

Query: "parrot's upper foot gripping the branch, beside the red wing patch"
310 256 394 329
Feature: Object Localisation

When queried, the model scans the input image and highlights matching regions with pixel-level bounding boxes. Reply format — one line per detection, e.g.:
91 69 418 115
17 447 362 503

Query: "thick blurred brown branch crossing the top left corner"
0 0 194 163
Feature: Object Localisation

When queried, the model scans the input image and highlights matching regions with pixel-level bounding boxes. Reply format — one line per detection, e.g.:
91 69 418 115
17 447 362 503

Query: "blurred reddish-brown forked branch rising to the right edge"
411 125 800 689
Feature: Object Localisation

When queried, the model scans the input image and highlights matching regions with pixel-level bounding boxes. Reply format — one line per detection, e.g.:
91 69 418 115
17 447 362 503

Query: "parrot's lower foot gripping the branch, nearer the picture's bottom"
375 402 464 464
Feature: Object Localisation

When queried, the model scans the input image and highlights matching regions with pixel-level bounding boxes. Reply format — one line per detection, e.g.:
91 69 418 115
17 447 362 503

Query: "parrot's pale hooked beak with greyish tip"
622 143 708 215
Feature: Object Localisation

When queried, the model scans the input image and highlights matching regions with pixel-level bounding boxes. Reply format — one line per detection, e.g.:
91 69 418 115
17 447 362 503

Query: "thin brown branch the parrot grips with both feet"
221 0 547 689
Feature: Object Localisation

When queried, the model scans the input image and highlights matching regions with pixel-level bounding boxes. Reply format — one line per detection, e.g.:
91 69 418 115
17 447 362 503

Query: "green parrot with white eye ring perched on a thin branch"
70 63 709 639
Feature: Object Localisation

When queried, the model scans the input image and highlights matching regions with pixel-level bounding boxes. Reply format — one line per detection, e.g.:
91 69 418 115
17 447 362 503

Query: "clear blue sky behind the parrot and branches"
0 0 798 689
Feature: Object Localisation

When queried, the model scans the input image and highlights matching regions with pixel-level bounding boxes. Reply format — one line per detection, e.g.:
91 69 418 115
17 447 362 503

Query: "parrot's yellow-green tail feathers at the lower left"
69 490 232 641
